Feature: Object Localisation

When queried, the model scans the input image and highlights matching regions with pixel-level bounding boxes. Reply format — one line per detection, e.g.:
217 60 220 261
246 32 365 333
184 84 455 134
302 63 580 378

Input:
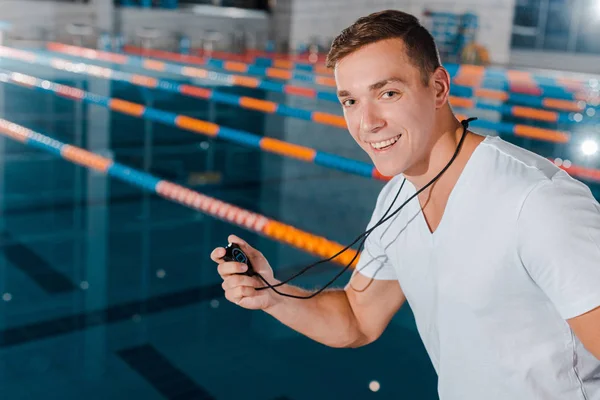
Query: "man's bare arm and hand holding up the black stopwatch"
211 235 405 347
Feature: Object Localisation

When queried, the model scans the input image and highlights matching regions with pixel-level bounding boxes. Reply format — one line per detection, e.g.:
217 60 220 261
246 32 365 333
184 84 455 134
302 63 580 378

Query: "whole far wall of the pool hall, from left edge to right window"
0 0 515 64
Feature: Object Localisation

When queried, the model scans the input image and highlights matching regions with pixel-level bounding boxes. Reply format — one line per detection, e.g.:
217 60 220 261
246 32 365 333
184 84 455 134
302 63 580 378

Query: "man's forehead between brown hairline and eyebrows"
334 39 419 92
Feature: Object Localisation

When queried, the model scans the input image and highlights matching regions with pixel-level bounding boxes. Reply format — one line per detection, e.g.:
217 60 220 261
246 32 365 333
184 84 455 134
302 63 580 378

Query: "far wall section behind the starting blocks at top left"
0 0 268 52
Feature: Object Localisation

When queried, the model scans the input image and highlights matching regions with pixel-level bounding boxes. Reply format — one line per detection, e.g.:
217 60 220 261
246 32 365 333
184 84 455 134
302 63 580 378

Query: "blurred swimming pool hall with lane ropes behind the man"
0 0 600 400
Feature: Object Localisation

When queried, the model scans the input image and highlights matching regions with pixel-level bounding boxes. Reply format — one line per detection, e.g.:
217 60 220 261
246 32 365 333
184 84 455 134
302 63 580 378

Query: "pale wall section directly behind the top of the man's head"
282 0 515 64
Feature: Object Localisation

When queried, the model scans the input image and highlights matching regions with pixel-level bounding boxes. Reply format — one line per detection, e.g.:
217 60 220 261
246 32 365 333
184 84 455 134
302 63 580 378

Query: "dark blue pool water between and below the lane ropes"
0 52 598 400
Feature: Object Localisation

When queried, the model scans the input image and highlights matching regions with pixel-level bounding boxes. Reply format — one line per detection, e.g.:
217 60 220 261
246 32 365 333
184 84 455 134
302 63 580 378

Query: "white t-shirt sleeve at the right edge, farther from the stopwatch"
517 171 600 319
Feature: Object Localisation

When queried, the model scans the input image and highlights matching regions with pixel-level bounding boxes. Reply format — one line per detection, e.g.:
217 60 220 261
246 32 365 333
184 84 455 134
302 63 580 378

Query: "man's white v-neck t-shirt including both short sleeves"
357 137 600 400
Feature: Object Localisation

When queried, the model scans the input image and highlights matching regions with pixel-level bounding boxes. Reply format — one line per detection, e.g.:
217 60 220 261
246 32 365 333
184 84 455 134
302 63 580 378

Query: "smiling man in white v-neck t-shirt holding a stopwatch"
211 11 600 400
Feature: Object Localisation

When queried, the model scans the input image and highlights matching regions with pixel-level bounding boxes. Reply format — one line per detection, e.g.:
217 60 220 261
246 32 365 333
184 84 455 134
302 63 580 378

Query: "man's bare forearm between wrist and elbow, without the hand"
265 285 366 347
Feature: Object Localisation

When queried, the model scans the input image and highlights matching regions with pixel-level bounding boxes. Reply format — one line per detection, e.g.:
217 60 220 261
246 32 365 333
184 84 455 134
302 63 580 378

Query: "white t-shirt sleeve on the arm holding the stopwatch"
356 184 397 280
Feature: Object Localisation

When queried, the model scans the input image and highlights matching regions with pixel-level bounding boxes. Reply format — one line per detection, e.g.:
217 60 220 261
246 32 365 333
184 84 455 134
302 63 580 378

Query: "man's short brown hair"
327 10 441 85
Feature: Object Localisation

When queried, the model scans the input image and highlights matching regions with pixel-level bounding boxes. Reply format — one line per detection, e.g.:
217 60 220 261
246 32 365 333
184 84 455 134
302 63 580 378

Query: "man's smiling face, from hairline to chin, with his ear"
335 39 444 176
